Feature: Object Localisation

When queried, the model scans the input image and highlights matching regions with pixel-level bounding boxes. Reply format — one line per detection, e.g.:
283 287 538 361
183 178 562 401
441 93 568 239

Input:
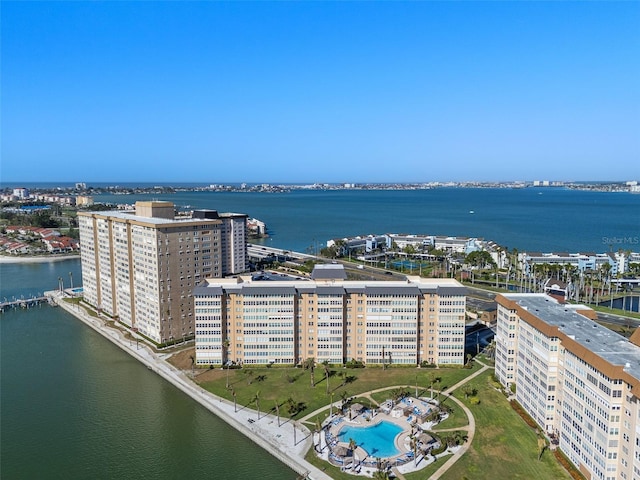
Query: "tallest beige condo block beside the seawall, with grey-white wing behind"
78 201 247 344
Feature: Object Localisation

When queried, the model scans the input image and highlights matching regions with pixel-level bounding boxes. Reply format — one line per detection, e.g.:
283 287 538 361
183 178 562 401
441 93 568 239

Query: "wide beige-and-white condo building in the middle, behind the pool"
194 264 466 365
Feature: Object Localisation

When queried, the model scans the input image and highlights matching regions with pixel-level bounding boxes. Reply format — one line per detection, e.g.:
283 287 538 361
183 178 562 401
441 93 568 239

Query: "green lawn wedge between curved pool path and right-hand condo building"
440 371 571 480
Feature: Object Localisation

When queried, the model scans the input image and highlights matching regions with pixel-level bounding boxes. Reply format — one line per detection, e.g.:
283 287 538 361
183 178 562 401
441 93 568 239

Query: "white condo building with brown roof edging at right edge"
495 294 640 480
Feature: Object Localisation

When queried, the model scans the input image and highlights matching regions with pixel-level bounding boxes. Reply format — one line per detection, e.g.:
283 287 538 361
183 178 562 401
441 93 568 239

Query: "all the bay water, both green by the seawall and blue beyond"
0 188 640 479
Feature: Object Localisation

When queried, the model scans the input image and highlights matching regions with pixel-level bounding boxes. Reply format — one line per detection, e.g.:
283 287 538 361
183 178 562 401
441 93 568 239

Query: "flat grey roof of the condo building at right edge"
502 293 640 380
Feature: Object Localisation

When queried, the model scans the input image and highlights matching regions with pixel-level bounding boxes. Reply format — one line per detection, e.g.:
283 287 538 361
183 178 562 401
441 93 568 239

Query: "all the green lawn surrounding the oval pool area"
198 365 570 480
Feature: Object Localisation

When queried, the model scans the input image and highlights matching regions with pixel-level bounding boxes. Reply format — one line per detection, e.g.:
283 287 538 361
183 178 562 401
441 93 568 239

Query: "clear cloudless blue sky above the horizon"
0 1 640 184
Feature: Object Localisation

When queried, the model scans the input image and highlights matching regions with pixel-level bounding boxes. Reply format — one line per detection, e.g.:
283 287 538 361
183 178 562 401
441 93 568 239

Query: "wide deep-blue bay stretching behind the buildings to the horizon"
95 188 640 252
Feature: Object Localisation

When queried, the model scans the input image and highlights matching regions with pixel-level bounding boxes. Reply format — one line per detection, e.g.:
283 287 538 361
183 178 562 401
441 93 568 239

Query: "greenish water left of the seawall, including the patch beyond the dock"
0 260 296 480
